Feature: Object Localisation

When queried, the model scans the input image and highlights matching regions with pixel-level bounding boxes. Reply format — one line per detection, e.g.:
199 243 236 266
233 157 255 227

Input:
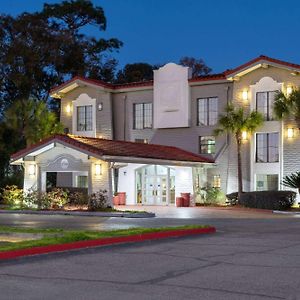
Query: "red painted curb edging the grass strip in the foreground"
0 227 216 260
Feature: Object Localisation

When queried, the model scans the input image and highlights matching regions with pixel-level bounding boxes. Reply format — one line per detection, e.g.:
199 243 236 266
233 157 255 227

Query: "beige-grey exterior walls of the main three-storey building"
55 61 300 196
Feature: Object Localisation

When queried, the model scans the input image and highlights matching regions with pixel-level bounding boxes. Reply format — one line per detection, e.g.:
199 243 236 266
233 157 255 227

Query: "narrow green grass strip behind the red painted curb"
0 225 209 252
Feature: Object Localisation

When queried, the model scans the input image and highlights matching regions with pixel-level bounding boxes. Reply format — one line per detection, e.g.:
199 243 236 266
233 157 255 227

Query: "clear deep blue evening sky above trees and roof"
0 0 300 73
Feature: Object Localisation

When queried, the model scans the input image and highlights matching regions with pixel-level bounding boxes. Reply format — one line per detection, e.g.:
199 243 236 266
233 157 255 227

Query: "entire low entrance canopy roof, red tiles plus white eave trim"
11 135 214 166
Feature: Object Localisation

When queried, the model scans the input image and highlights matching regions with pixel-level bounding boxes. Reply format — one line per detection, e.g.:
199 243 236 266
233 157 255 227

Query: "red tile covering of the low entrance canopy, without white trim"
11 134 214 163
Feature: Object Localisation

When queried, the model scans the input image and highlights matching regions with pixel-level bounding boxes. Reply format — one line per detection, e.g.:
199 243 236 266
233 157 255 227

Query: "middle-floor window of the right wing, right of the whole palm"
256 132 279 163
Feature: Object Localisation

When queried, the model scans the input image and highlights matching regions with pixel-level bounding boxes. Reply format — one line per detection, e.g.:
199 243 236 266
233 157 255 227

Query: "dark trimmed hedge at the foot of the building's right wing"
239 191 296 210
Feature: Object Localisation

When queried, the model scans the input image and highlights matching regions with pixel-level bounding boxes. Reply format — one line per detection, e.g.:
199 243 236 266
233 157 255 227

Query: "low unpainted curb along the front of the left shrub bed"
0 210 155 218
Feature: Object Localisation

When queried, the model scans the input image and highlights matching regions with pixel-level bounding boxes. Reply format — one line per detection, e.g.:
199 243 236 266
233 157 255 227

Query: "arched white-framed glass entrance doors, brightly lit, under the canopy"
136 165 175 205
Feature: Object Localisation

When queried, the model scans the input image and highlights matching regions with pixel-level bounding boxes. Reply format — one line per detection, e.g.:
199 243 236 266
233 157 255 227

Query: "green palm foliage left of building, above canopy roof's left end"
4 99 63 146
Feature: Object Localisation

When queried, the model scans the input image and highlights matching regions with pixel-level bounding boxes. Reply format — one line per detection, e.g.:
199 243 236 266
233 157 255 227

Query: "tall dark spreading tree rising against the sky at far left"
0 0 122 117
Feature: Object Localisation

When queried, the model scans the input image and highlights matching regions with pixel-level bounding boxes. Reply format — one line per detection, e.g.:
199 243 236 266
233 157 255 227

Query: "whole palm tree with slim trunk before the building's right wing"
214 103 263 199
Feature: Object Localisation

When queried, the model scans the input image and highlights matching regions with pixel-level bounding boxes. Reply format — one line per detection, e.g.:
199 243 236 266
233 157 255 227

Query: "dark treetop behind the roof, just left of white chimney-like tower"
116 63 154 83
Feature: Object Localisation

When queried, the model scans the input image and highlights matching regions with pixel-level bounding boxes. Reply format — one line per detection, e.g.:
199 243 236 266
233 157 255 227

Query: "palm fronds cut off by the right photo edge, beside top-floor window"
274 89 300 128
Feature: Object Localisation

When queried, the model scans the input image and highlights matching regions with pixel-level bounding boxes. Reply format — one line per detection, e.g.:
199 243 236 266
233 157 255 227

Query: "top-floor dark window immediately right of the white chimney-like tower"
197 97 218 126
